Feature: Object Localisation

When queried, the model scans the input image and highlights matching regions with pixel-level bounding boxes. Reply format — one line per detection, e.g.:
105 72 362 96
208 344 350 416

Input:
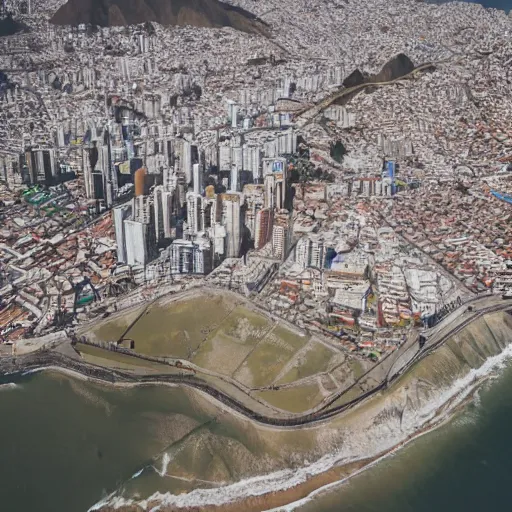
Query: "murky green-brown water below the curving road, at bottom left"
0 373 214 512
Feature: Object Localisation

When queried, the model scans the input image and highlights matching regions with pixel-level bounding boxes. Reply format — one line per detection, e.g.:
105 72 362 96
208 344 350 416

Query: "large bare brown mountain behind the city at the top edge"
51 0 268 35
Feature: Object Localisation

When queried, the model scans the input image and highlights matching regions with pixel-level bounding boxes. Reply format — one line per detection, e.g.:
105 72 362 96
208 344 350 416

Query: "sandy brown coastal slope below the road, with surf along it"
91 312 512 512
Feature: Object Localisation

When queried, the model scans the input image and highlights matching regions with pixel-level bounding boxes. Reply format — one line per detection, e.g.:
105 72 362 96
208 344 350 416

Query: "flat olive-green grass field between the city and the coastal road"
87 291 360 396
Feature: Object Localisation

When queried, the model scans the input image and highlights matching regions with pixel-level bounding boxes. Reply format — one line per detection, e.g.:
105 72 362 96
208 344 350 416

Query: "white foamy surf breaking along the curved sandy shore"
90 344 512 512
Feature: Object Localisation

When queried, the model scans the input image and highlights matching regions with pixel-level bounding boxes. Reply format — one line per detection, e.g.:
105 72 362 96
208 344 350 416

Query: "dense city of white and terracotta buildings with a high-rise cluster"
0 0 512 360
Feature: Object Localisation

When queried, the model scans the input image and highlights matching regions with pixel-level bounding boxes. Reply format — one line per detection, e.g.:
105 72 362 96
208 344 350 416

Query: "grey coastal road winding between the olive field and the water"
0 296 512 428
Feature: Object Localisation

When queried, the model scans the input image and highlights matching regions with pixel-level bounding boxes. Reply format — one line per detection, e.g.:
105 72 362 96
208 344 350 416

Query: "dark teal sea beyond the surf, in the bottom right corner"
296 356 512 512
